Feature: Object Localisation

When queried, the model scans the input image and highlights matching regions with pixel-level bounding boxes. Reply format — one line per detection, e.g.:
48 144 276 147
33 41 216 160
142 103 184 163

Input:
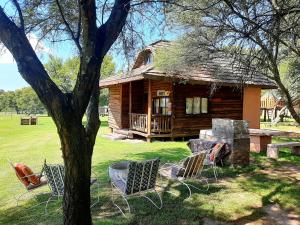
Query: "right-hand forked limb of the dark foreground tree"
73 0 130 116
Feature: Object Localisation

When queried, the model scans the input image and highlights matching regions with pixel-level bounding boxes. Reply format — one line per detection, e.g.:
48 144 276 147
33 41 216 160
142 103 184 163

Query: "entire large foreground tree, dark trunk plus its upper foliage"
0 0 169 225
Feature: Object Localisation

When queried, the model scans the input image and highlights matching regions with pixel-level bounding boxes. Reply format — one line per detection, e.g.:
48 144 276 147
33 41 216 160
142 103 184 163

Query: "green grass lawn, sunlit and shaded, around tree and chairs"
0 116 300 225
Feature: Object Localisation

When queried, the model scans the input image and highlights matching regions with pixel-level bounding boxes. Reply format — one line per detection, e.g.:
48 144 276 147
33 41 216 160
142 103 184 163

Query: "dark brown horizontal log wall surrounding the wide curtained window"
172 84 243 136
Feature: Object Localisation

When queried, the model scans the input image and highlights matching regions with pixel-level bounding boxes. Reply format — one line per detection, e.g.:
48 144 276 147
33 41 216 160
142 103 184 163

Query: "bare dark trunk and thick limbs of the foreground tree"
0 0 130 225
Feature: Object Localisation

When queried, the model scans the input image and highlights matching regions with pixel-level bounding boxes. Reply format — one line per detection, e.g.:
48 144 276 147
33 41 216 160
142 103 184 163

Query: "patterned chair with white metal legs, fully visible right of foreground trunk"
111 159 162 216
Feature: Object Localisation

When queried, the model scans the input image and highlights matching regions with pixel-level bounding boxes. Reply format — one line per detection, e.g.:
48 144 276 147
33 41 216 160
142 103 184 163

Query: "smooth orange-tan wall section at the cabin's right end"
243 87 261 129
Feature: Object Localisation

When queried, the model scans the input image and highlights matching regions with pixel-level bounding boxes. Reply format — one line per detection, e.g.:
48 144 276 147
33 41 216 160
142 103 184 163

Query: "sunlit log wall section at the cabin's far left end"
108 84 121 129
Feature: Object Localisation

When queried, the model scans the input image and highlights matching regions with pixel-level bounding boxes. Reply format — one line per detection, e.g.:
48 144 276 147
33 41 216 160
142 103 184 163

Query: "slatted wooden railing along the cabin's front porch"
129 113 172 134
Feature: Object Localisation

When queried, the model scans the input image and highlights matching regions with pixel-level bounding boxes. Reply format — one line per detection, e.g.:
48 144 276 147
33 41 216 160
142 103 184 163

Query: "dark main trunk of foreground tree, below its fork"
59 119 93 225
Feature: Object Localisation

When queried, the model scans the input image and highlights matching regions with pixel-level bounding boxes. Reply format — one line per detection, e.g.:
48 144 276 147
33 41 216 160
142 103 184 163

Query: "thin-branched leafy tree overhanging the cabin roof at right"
164 0 300 124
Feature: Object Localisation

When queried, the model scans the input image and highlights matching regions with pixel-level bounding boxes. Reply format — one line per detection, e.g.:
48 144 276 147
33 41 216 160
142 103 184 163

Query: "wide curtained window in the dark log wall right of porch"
185 97 208 115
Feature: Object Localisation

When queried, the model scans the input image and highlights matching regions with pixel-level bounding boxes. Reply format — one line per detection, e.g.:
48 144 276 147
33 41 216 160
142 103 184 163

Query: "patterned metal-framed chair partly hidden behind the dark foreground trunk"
44 163 100 213
